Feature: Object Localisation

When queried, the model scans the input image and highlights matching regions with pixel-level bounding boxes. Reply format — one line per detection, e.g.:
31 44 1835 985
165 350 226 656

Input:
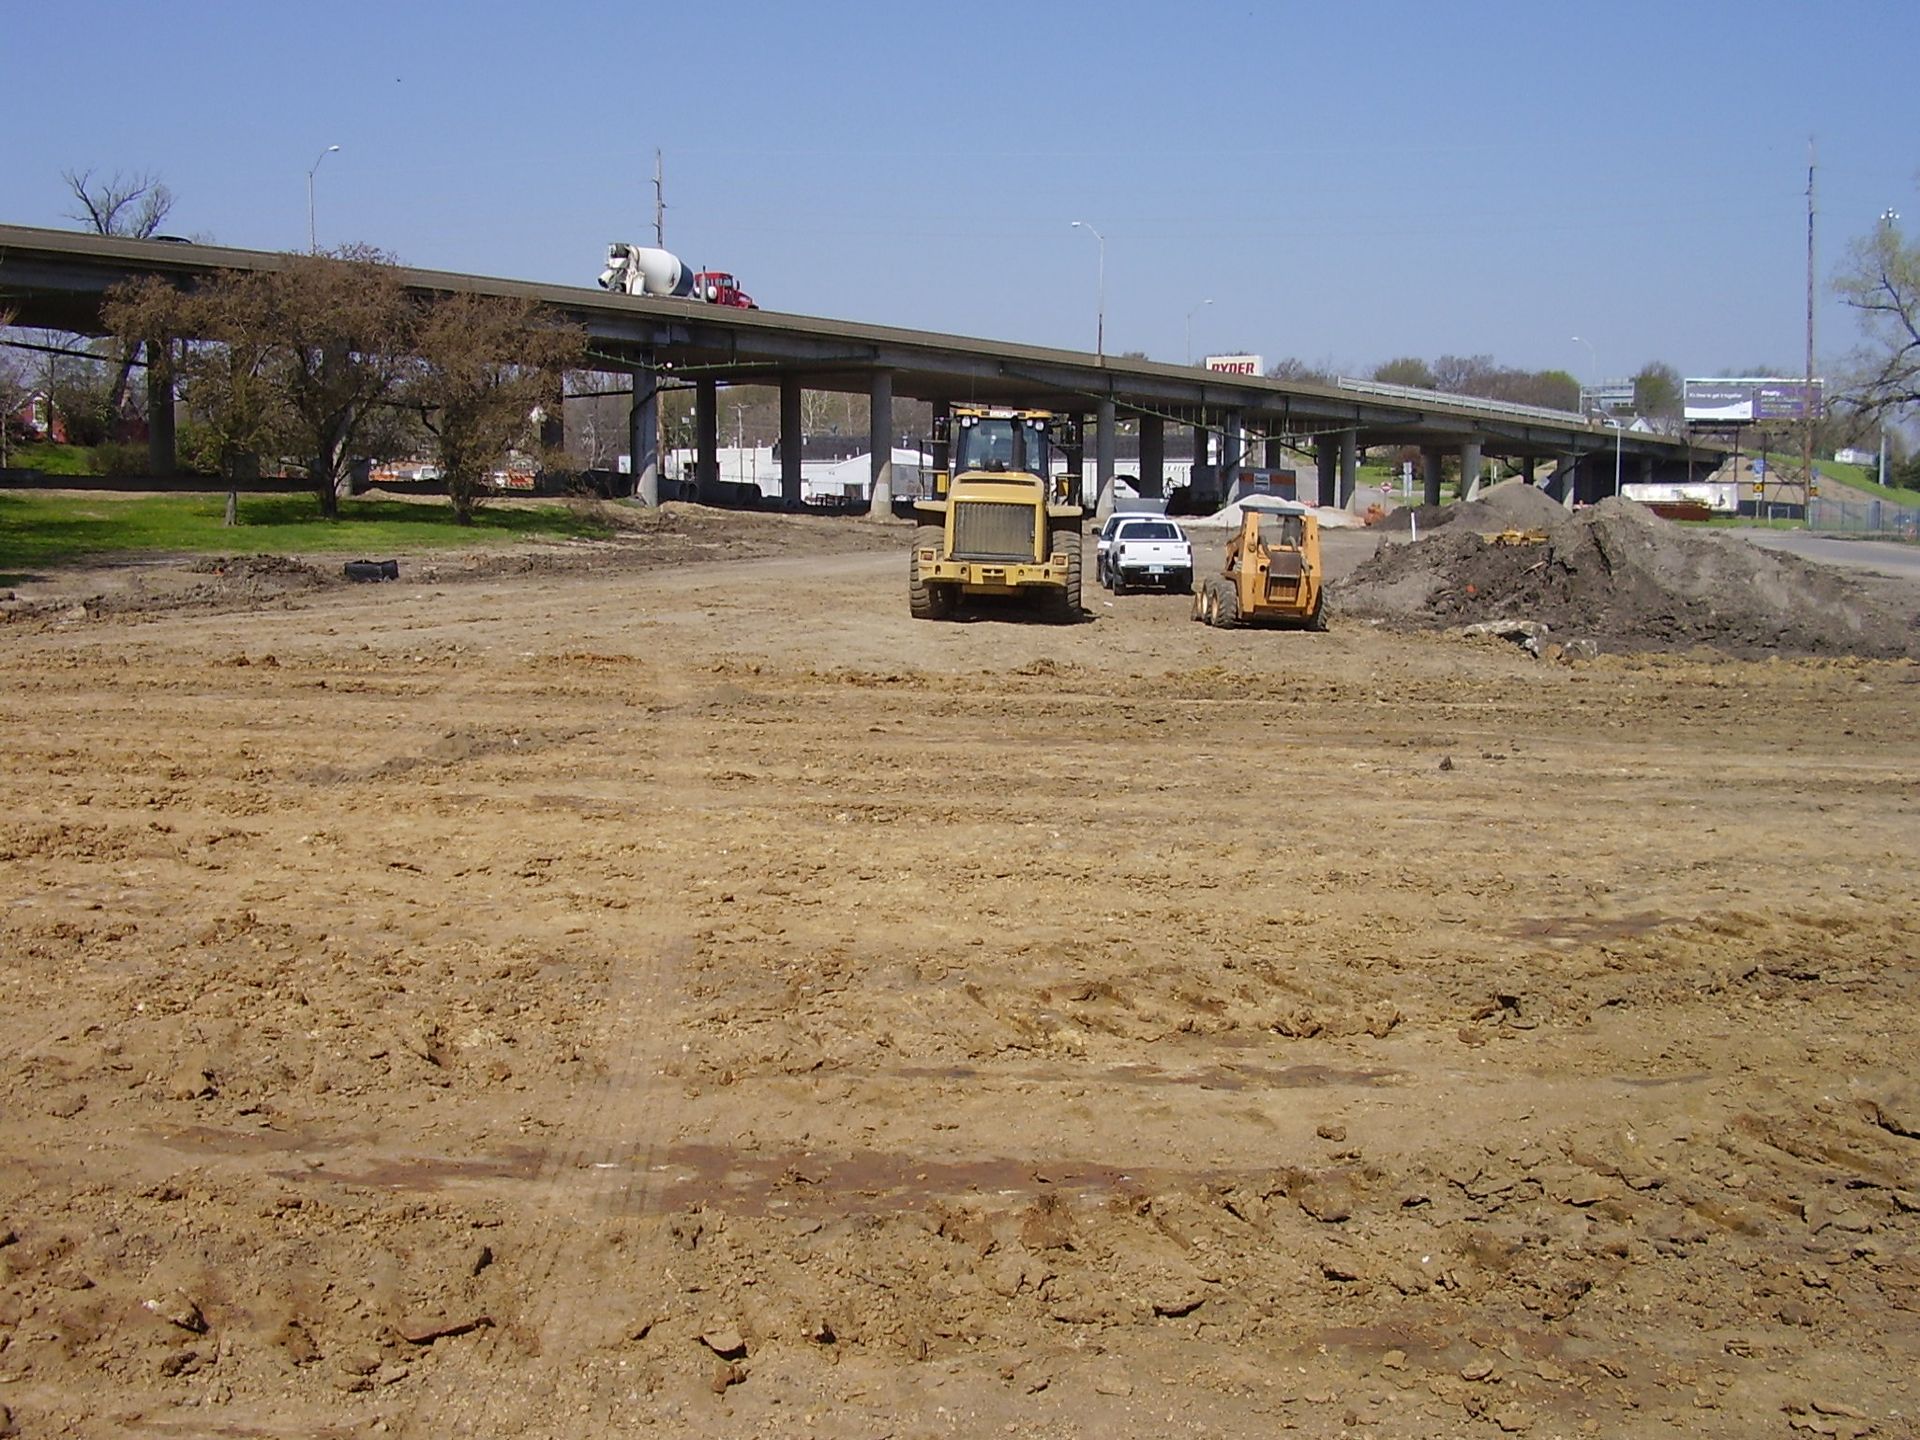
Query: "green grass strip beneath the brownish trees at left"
0 492 607 584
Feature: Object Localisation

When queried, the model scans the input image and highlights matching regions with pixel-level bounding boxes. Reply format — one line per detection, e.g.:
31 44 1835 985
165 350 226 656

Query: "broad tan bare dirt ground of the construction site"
0 516 1920 1440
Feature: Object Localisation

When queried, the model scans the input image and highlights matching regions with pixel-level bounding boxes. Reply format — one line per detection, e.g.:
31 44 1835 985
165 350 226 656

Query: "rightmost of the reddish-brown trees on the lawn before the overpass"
399 296 586 524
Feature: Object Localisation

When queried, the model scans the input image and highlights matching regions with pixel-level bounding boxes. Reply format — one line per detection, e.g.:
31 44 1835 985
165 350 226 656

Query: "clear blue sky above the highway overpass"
0 0 1920 376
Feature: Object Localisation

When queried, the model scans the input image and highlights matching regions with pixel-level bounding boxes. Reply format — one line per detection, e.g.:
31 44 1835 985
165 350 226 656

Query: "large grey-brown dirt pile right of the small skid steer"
1334 486 1920 659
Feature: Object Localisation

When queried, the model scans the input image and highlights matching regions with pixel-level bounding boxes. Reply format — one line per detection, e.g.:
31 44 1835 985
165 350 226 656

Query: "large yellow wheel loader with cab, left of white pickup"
906 405 1085 624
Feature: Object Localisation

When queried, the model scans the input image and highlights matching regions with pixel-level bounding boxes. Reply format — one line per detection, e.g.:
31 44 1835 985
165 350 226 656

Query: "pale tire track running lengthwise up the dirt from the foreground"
396 666 712 1440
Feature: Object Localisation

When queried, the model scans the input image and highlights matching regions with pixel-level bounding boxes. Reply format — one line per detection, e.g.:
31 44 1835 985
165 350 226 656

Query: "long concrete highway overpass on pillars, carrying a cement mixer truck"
0 225 1720 509
